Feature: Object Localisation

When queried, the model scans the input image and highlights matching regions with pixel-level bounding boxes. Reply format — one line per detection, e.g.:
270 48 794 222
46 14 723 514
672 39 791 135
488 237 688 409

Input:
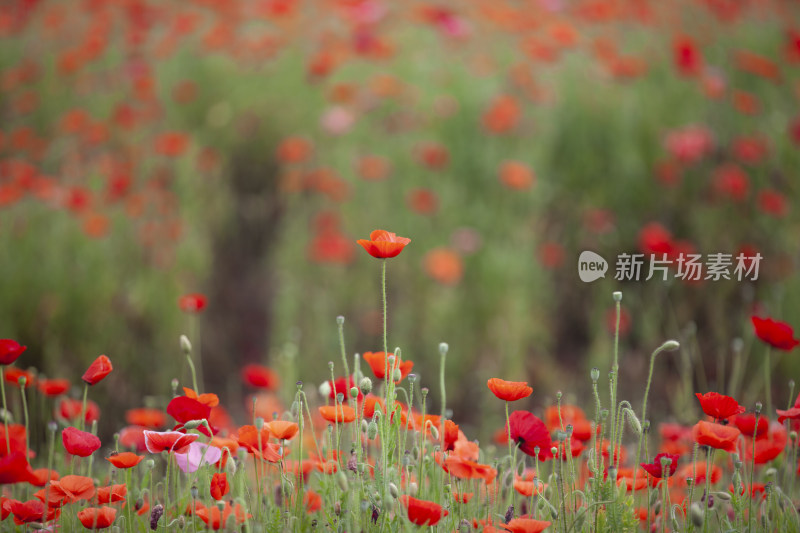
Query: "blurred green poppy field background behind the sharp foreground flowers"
0 0 800 435
